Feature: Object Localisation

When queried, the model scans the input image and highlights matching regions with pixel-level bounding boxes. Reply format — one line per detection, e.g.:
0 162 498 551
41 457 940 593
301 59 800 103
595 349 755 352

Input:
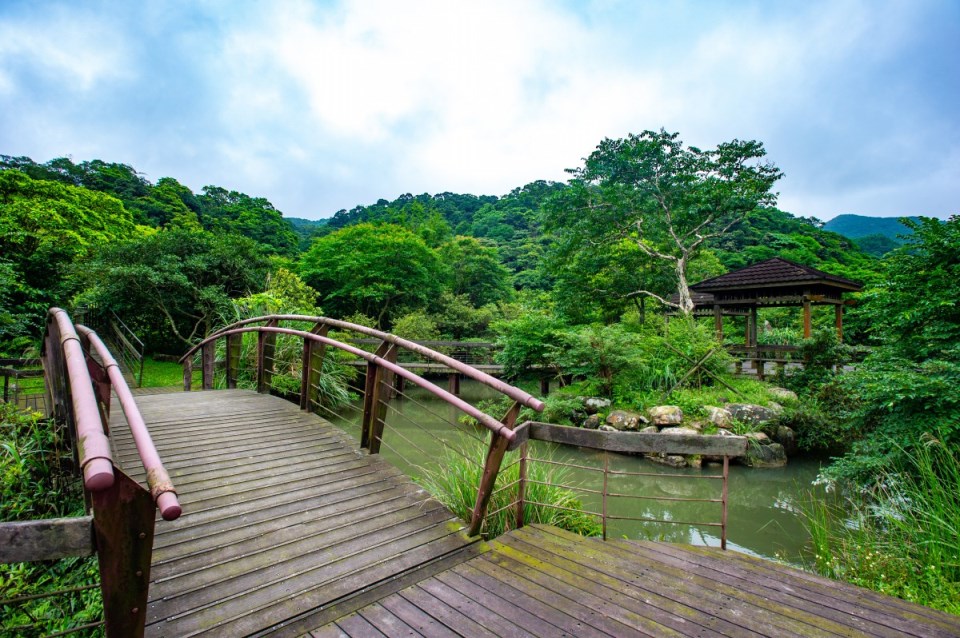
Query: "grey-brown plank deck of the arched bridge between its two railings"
111 390 473 638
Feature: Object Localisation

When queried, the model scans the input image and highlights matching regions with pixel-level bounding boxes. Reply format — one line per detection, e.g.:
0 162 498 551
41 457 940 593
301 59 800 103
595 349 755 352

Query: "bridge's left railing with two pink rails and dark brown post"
0 308 181 636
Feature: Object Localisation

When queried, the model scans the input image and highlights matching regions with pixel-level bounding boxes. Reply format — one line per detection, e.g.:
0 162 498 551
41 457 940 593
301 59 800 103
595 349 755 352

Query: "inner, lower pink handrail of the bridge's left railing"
77 325 183 521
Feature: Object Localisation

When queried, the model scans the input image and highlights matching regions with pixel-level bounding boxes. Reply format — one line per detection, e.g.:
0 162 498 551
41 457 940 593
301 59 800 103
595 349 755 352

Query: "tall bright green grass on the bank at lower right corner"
806 437 960 614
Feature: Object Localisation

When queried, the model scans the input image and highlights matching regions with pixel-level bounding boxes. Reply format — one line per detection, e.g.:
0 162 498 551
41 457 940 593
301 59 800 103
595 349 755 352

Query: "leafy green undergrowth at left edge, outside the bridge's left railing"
0 403 103 636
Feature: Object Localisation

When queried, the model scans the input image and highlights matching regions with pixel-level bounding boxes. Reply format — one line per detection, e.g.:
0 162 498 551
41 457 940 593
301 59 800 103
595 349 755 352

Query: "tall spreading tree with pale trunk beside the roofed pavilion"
546 129 782 313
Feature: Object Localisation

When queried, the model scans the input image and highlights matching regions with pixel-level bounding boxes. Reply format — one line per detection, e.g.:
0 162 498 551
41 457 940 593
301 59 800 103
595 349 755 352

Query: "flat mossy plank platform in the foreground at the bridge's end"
316 525 960 638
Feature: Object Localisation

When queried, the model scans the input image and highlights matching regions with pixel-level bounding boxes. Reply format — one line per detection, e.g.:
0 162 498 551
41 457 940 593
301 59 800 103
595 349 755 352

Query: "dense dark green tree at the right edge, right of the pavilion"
829 216 960 482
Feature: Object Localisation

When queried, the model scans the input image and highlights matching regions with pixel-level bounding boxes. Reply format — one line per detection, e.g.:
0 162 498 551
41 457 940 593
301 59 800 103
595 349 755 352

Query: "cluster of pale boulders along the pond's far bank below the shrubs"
573 388 797 468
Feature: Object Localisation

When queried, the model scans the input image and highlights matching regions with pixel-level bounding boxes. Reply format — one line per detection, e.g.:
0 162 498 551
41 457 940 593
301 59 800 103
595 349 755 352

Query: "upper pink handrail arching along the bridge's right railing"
188 315 544 416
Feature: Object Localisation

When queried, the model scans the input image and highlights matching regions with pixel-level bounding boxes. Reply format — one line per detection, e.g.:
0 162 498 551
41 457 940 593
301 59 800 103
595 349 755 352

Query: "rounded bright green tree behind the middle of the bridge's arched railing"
300 224 446 327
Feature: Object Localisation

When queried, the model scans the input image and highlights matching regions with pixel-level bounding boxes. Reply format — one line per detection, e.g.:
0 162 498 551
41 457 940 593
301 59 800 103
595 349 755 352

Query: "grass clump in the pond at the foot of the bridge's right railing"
416 443 602 538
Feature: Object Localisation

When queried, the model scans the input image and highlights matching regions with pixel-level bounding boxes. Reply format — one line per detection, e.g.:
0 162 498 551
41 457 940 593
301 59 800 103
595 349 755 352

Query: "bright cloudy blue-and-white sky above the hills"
0 0 960 220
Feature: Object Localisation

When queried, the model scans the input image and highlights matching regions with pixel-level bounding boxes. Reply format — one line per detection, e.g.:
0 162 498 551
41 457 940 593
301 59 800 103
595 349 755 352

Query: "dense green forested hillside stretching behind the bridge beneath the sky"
0 149 876 353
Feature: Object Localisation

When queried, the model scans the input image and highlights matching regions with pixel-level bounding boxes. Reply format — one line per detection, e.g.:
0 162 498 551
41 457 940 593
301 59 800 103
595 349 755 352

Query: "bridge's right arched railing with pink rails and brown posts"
180 315 544 535
